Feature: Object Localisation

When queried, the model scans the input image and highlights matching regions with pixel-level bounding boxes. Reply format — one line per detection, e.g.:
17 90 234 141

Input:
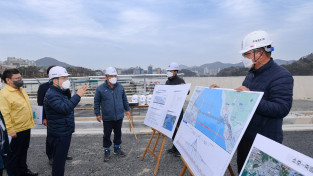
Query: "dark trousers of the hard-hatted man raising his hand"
48 134 72 176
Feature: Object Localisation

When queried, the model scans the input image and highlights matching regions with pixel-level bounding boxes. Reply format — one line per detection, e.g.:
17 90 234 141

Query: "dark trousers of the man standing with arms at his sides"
103 119 123 148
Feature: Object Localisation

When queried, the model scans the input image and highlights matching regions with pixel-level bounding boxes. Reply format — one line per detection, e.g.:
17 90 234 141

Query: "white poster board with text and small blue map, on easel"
144 84 191 138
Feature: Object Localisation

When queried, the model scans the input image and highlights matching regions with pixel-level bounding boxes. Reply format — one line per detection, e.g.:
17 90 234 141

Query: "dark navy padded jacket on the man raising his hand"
44 86 80 136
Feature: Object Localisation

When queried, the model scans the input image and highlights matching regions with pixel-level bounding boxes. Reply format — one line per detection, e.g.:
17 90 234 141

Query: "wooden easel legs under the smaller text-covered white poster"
141 128 166 175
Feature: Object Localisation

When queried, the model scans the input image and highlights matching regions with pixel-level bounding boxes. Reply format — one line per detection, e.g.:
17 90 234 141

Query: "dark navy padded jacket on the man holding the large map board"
242 59 293 143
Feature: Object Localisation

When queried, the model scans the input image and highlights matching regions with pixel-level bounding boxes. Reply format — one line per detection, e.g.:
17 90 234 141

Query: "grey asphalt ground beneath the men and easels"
4 131 313 176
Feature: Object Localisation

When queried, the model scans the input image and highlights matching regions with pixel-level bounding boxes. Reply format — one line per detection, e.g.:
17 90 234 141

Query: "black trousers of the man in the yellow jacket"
6 129 30 176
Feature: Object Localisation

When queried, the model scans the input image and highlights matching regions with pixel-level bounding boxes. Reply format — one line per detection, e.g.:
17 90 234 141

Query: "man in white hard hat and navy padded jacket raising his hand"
44 66 88 176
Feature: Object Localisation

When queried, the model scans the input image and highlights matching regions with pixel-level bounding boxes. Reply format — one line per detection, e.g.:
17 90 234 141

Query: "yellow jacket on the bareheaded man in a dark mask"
0 84 35 134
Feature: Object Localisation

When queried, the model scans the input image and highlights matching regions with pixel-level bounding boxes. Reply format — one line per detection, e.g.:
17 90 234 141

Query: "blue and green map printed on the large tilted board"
183 87 262 153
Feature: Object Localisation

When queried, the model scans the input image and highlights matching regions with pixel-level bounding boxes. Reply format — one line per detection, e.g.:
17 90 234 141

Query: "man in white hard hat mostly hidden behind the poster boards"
165 62 185 157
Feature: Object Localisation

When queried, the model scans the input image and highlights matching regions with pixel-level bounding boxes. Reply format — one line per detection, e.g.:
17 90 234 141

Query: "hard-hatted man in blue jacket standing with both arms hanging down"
94 67 130 162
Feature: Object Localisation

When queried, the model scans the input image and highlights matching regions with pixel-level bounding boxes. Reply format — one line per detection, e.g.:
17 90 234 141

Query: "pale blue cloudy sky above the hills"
0 0 313 69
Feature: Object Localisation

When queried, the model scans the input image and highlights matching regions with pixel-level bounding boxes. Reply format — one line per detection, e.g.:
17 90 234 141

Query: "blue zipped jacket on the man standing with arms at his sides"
94 82 129 121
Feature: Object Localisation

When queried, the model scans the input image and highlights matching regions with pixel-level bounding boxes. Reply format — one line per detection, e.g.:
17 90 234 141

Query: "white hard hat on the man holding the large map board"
240 31 273 53
